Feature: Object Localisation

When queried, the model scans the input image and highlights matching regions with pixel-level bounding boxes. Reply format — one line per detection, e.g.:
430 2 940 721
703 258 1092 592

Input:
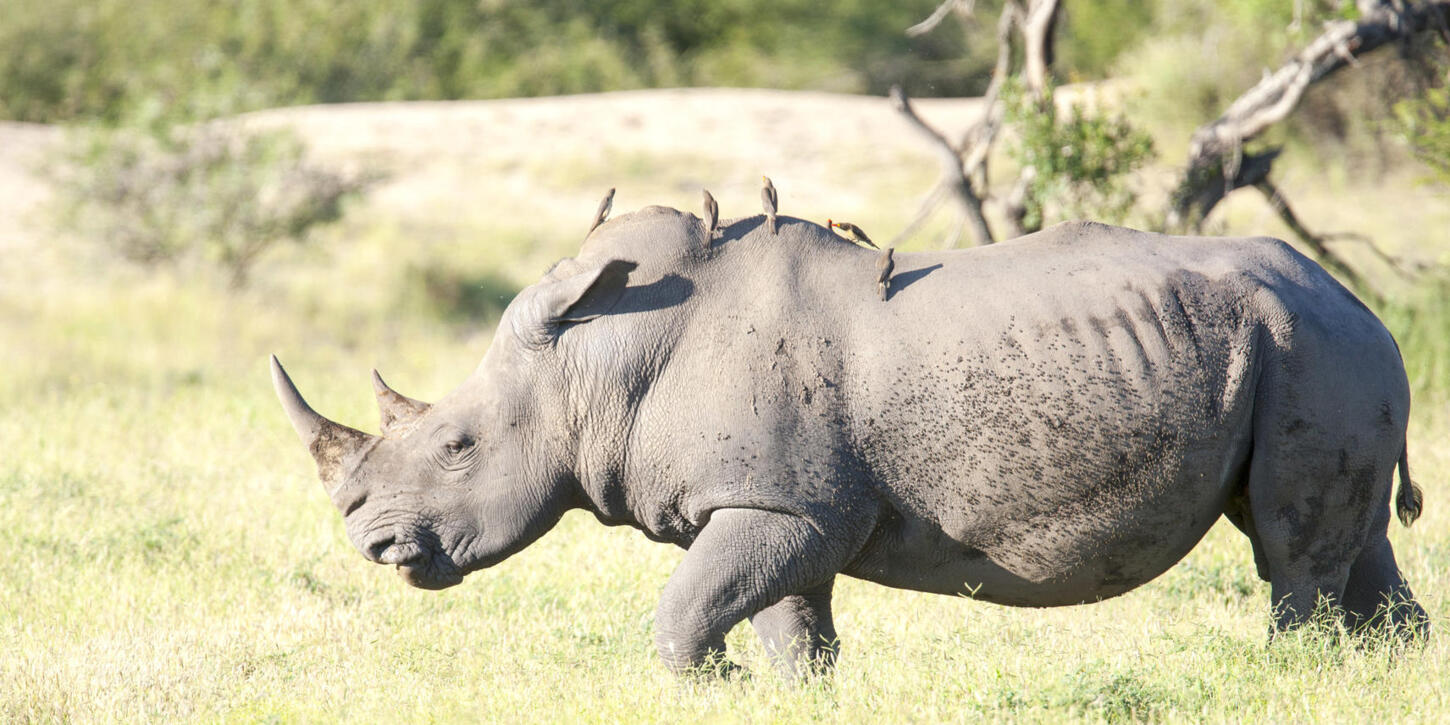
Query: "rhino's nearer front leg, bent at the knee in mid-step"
655 509 853 673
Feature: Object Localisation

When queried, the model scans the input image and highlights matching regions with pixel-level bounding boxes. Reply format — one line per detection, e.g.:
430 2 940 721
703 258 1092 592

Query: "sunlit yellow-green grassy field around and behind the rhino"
0 96 1450 722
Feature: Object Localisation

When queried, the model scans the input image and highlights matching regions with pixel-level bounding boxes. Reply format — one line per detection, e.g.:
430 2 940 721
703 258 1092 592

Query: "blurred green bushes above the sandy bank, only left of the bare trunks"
0 0 990 122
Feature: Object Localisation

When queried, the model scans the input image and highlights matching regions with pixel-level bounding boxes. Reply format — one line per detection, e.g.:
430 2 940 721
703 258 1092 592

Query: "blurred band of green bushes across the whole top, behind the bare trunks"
0 0 1409 122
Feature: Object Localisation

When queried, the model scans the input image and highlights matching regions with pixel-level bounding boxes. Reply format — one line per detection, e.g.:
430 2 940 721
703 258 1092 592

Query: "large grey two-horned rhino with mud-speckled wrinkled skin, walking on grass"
273 207 1428 671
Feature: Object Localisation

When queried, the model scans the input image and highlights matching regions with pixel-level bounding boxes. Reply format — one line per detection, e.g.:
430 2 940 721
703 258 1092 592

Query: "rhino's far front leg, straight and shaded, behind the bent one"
750 577 838 677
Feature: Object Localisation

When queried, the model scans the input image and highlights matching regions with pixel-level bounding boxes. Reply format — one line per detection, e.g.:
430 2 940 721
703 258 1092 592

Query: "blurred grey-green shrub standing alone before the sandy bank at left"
52 120 371 289
